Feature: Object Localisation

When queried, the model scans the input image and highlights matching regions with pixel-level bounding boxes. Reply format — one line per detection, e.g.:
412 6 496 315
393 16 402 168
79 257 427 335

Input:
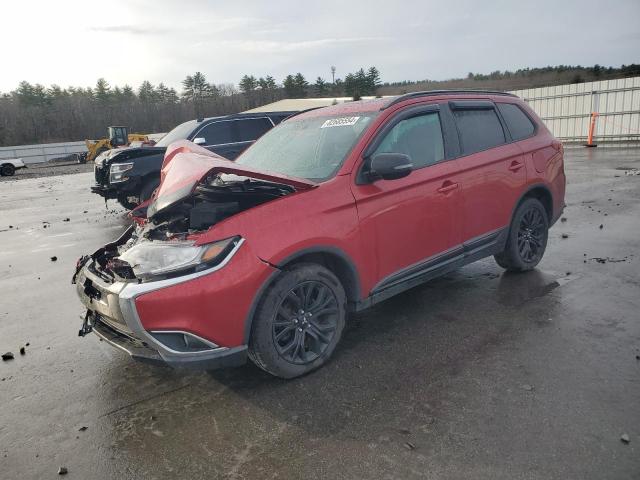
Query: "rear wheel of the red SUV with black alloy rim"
494 198 549 272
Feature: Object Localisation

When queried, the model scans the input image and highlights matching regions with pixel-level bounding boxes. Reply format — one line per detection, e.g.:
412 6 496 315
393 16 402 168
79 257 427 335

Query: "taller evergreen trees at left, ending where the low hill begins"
0 67 380 146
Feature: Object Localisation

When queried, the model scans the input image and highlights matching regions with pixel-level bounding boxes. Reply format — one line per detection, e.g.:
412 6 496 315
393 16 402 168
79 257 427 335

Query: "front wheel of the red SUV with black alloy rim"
249 263 346 378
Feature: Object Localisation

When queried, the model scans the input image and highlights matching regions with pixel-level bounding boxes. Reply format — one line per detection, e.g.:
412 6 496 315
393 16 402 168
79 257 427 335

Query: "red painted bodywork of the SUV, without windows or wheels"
130 94 565 346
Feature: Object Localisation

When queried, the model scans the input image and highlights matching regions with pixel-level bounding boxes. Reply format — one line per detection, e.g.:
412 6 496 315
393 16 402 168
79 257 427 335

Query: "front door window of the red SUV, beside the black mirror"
374 112 444 169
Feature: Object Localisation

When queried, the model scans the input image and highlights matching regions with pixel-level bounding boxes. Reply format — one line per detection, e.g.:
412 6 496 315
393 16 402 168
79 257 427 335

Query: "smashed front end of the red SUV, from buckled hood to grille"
73 141 313 368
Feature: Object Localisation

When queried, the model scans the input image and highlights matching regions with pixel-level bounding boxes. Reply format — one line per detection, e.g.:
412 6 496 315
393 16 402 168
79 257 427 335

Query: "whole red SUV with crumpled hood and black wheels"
75 91 565 378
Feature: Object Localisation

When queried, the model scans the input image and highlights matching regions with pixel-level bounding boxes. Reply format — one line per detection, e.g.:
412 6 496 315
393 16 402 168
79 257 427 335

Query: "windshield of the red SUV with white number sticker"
236 113 377 182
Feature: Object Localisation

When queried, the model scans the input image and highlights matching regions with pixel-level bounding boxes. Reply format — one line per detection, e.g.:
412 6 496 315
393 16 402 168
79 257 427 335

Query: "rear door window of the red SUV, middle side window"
453 108 506 155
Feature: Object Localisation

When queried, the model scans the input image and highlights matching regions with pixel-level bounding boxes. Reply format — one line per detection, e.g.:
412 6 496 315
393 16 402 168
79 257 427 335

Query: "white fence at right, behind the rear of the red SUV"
511 77 640 143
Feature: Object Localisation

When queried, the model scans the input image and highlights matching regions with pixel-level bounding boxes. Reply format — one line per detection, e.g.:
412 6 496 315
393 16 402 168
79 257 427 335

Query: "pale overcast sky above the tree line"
0 0 640 92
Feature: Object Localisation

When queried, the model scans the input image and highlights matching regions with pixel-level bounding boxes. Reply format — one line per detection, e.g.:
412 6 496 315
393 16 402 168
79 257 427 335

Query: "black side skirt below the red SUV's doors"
353 227 509 311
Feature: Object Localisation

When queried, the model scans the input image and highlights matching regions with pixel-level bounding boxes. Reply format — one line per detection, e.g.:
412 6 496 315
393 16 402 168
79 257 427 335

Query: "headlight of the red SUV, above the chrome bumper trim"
119 237 240 279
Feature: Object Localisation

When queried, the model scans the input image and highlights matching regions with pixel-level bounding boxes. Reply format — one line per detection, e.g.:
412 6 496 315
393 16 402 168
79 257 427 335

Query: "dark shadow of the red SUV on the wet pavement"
202 266 555 436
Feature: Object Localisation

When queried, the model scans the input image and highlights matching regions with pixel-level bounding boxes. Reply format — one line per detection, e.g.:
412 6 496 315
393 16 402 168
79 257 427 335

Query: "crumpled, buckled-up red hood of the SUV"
147 140 317 218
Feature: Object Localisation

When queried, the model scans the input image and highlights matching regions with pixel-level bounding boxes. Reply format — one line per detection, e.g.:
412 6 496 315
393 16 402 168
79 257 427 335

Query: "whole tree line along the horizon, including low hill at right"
0 64 640 146
